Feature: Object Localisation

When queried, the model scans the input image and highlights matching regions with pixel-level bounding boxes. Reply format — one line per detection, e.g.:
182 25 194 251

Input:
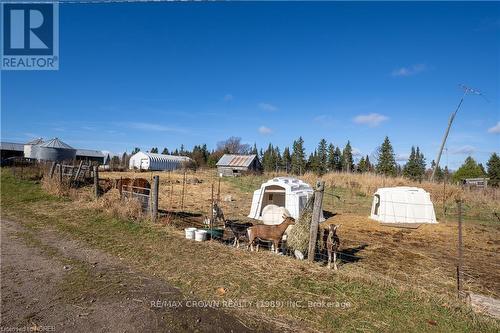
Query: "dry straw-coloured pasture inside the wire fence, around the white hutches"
101 170 500 297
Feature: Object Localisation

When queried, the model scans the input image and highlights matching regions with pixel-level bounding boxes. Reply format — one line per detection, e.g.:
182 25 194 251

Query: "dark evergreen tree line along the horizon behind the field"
106 136 500 186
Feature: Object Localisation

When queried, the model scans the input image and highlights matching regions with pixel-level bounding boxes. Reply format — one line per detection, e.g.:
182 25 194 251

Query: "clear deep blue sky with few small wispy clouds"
1 2 500 168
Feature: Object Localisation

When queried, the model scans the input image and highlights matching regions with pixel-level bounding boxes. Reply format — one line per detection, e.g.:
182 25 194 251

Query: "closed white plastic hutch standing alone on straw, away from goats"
370 186 437 225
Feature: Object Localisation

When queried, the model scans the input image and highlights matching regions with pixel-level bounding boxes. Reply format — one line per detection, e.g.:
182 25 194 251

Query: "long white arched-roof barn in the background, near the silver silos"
129 151 192 171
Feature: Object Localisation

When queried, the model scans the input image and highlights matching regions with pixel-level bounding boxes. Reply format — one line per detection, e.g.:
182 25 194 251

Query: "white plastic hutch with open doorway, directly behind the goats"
248 177 325 224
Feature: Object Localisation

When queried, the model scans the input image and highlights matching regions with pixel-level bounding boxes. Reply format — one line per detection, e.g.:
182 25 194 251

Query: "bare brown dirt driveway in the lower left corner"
0 220 282 332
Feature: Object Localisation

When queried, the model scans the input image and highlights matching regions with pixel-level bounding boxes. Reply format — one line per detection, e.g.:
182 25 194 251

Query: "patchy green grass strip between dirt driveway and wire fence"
1 170 500 332
